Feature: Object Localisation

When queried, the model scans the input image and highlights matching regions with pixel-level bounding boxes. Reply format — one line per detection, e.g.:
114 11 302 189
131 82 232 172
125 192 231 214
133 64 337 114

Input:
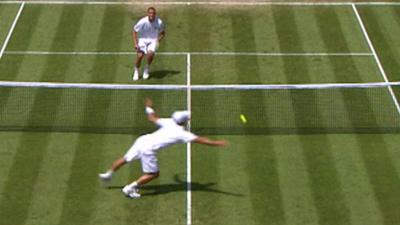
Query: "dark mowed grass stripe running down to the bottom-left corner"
0 5 83 225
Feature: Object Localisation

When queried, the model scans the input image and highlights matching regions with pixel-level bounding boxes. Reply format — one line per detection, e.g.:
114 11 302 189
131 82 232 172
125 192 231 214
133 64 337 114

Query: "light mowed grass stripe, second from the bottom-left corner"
22 7 87 224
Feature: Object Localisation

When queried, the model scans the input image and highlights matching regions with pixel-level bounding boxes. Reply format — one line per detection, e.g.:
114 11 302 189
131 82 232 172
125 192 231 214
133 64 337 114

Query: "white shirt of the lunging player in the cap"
135 118 197 153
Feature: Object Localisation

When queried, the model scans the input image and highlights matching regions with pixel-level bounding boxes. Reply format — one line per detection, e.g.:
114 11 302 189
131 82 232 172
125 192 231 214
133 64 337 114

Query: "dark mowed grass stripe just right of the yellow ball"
231 11 285 224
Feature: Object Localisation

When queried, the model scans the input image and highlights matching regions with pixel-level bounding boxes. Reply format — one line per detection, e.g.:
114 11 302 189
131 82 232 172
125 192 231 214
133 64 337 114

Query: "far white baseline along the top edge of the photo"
0 1 400 6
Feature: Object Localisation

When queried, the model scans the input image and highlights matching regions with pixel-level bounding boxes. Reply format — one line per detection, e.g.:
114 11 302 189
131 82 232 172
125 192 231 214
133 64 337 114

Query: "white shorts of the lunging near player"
124 138 159 173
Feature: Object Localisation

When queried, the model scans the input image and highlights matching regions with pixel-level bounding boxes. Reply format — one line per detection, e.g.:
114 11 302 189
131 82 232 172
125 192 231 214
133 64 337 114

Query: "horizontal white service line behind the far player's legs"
5 51 374 57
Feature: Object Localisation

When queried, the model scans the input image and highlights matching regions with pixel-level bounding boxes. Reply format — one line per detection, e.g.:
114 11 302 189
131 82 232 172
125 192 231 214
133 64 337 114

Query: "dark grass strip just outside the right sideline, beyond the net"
359 7 400 81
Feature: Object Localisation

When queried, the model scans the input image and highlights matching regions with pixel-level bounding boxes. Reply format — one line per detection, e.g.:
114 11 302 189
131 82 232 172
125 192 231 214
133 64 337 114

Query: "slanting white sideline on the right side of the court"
352 4 400 115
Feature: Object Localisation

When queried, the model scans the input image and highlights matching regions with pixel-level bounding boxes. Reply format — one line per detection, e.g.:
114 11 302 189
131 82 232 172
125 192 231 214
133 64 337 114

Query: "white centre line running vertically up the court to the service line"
186 53 192 225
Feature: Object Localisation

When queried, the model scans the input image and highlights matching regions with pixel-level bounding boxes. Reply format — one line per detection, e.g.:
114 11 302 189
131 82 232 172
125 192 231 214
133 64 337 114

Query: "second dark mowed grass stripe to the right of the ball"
273 7 350 225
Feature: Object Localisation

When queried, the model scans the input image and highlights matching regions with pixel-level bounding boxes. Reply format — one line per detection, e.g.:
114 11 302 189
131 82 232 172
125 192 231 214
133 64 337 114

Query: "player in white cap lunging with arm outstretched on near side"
99 98 225 198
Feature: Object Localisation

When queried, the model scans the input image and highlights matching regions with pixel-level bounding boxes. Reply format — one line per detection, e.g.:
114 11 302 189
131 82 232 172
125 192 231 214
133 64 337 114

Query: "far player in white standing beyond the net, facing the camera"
132 7 165 81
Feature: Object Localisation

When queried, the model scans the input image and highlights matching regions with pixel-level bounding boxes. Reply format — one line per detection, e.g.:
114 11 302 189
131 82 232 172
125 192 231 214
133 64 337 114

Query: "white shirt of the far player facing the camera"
133 16 164 40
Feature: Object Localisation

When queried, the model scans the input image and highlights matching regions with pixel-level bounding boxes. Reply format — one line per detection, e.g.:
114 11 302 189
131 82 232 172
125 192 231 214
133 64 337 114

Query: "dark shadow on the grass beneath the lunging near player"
109 174 244 197
